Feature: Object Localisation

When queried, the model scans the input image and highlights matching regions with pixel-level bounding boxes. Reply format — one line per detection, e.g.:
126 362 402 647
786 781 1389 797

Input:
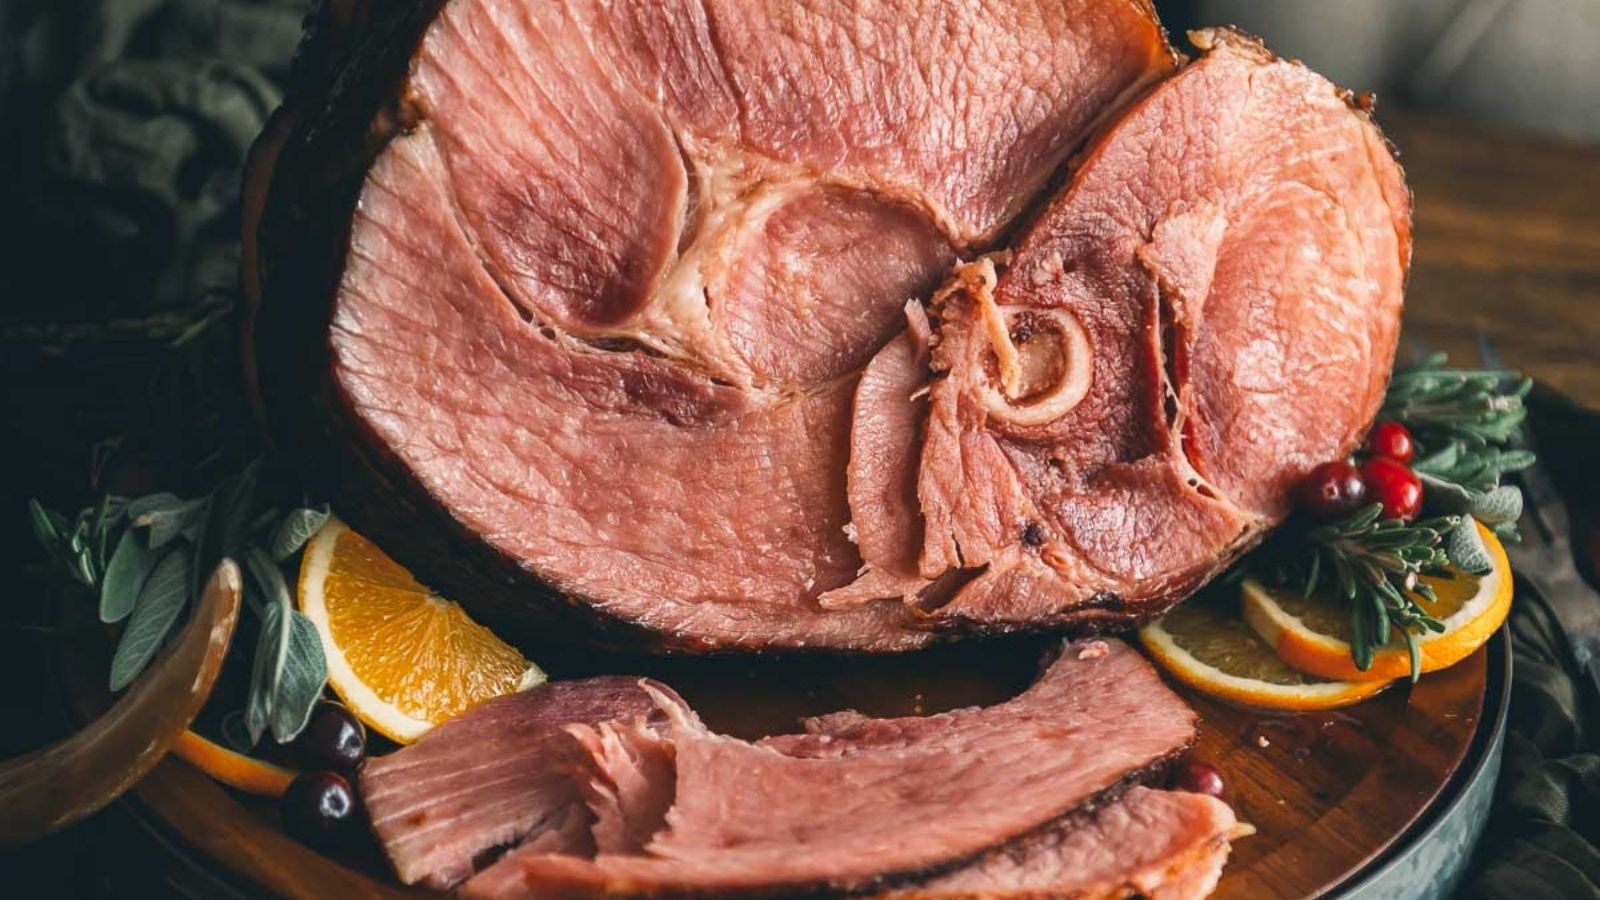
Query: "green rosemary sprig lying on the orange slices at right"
1253 503 1458 681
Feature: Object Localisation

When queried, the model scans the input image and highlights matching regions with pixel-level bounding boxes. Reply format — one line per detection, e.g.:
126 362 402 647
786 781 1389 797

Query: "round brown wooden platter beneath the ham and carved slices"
62 586 1509 900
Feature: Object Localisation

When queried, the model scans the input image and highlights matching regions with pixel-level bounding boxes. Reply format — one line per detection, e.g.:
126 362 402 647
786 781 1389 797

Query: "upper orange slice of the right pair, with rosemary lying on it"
1240 522 1512 682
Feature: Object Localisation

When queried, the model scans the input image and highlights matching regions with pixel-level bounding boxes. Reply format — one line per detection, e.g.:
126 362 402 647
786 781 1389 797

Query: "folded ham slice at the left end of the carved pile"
360 676 666 889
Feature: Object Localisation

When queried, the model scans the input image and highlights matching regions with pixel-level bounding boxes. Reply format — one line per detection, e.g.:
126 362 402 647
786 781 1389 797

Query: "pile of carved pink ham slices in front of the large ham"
362 642 1248 898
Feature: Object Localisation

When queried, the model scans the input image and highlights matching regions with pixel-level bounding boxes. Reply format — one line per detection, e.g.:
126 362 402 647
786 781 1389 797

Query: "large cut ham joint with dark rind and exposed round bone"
253 0 1410 650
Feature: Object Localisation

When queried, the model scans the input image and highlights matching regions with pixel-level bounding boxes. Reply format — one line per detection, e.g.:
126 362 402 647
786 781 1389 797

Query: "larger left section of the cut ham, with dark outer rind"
256 0 1173 650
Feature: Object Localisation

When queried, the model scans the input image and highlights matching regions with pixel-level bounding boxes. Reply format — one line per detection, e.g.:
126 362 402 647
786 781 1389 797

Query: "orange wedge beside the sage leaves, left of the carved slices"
299 517 544 743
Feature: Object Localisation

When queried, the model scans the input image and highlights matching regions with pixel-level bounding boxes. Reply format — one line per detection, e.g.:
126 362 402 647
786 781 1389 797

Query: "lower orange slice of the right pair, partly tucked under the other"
1139 593 1387 709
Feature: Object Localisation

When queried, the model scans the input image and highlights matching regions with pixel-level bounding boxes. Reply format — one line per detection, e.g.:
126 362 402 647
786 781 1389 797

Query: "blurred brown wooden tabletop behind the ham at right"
1384 115 1600 408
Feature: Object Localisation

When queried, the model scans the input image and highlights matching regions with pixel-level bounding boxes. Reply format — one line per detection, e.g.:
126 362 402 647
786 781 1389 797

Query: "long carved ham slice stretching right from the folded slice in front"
462 642 1195 898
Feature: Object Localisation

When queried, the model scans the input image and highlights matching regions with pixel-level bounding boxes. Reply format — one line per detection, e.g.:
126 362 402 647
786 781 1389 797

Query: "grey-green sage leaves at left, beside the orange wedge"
29 463 328 743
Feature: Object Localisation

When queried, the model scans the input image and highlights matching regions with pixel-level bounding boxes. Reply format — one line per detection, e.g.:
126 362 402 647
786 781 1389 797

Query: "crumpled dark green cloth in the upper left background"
0 0 306 322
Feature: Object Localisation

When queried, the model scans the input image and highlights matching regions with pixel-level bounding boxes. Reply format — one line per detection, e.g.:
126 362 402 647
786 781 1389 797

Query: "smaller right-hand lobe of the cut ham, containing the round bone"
832 30 1411 631
